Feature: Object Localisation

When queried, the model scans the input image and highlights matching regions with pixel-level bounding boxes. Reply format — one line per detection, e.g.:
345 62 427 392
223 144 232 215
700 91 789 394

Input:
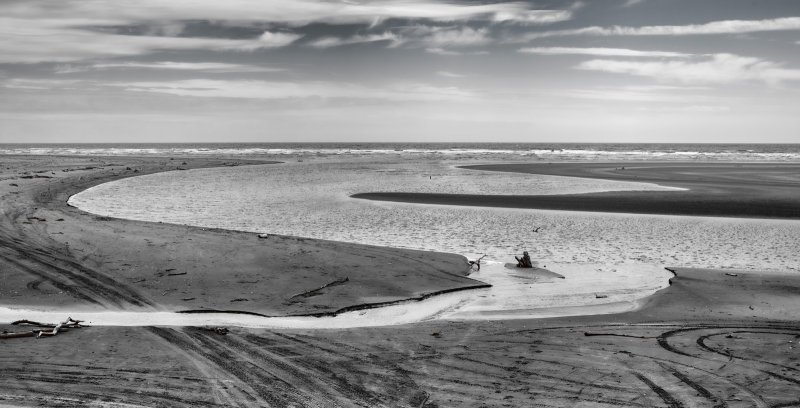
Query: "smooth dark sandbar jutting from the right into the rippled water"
353 162 800 219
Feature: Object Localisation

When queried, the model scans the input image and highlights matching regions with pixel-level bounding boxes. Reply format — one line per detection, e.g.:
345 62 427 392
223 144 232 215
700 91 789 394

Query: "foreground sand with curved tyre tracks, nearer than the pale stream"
0 269 800 407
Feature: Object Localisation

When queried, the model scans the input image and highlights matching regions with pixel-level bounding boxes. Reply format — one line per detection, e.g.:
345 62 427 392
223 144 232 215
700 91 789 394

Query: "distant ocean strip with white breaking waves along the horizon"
0 143 800 162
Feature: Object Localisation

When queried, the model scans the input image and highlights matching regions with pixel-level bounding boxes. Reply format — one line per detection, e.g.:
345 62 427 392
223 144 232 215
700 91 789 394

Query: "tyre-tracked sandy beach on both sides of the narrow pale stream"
0 156 800 408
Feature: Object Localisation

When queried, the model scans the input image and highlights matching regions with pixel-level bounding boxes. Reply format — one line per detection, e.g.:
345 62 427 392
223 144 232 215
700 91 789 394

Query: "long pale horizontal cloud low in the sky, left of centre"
113 79 474 102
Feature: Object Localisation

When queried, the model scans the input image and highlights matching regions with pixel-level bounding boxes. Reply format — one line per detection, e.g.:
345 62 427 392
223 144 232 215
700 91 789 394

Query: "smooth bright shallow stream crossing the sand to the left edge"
0 262 655 329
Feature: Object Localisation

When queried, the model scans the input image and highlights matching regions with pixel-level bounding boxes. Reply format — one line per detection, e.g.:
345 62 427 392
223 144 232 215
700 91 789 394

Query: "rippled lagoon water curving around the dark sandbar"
61 158 800 327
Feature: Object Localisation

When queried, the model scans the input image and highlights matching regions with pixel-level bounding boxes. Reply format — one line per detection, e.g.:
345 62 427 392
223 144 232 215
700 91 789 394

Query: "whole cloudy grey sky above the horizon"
0 0 800 143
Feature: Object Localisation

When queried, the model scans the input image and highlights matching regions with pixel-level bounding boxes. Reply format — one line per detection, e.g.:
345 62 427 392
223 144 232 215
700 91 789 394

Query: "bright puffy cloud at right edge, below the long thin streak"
576 54 800 85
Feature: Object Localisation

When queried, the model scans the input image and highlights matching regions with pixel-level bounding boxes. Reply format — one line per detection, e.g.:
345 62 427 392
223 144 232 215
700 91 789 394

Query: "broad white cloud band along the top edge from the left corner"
0 0 572 26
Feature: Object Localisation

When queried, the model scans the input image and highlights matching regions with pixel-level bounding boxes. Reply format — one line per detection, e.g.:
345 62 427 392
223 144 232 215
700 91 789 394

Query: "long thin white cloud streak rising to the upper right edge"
524 17 800 40
